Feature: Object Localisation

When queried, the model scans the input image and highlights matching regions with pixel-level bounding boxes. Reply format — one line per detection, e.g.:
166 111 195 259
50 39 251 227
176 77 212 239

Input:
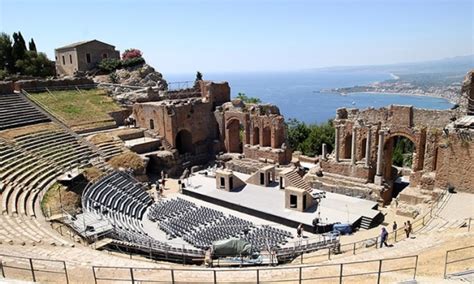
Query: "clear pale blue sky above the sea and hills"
0 0 474 73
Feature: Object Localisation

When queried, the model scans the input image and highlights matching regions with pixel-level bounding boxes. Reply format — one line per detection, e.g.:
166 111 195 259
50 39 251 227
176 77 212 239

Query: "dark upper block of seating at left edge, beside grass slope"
0 94 50 130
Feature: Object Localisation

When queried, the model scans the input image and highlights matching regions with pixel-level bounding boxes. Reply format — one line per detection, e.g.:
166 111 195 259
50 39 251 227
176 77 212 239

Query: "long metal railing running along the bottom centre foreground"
92 255 418 283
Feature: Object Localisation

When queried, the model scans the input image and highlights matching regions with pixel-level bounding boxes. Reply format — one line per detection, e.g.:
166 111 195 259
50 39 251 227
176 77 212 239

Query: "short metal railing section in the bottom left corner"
0 254 69 283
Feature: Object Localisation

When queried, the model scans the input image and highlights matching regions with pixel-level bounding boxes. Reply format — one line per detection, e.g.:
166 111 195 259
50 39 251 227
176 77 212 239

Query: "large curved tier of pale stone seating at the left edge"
0 125 103 245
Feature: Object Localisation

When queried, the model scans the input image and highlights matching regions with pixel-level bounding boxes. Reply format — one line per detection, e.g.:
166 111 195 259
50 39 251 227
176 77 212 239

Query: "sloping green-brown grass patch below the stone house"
28 89 121 130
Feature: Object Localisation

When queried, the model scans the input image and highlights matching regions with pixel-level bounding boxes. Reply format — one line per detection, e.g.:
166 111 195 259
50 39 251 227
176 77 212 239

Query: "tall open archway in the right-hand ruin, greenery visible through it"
384 135 416 198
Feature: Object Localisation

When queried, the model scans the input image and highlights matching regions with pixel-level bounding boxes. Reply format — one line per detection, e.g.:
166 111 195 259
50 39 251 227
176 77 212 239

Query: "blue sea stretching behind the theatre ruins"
164 71 452 123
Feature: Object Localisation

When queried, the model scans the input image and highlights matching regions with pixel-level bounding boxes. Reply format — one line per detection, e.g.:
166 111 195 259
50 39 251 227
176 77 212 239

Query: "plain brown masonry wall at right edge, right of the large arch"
435 130 474 193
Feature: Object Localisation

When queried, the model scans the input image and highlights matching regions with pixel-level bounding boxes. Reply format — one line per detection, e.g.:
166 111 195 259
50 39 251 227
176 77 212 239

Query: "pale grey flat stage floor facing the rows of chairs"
183 172 380 233
